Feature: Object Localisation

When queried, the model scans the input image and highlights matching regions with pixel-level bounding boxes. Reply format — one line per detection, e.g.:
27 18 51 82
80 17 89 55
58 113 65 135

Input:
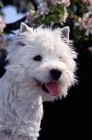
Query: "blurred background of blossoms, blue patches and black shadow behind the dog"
0 0 92 140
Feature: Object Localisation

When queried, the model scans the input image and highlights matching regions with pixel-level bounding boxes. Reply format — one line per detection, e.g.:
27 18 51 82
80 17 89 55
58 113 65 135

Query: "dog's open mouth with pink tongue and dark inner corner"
36 80 60 96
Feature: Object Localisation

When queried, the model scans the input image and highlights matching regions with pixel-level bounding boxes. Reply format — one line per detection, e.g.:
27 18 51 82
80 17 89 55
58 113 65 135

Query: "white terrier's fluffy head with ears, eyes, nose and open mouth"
6 23 76 101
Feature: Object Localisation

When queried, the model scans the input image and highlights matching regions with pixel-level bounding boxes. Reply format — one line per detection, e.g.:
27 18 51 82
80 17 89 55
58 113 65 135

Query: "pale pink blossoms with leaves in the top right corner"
66 0 92 43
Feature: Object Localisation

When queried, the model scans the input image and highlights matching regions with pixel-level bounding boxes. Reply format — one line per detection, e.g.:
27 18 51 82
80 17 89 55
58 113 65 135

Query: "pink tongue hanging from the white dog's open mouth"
45 82 59 96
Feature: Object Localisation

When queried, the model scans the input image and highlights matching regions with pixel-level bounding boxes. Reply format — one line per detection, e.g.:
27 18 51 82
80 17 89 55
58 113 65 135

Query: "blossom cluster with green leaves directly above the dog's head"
27 0 70 26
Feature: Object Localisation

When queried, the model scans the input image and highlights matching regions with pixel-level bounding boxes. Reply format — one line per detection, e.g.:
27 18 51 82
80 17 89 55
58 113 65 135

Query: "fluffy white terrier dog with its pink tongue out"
0 23 77 140
